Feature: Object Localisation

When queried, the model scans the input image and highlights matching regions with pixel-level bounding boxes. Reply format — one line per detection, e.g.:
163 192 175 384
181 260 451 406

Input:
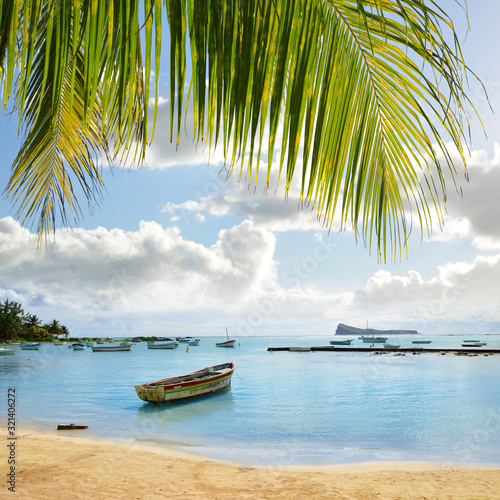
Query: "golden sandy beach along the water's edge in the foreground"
0 428 500 500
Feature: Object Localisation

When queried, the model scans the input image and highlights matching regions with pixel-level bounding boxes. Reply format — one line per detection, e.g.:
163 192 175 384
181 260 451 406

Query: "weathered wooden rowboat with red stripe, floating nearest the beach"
135 362 235 403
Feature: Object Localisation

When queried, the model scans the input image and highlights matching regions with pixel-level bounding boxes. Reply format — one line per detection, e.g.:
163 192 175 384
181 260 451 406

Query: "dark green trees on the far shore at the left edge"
0 299 69 342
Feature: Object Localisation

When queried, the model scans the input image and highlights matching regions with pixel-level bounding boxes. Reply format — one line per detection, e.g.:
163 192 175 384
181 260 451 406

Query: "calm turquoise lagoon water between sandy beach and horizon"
0 335 500 465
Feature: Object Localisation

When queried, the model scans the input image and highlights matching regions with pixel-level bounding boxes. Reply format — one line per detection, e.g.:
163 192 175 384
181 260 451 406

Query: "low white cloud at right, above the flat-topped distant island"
349 254 500 331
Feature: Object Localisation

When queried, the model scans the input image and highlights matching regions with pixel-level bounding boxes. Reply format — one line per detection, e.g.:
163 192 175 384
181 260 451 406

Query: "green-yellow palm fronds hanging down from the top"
0 0 484 260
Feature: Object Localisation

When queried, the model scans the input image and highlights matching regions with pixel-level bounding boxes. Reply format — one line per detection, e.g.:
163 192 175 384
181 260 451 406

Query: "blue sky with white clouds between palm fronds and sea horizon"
0 0 500 337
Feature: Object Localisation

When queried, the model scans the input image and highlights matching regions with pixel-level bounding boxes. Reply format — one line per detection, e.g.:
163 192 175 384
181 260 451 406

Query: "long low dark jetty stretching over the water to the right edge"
267 344 500 354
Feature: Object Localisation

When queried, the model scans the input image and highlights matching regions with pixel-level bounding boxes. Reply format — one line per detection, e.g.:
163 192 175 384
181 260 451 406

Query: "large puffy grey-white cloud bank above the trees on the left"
0 217 276 334
